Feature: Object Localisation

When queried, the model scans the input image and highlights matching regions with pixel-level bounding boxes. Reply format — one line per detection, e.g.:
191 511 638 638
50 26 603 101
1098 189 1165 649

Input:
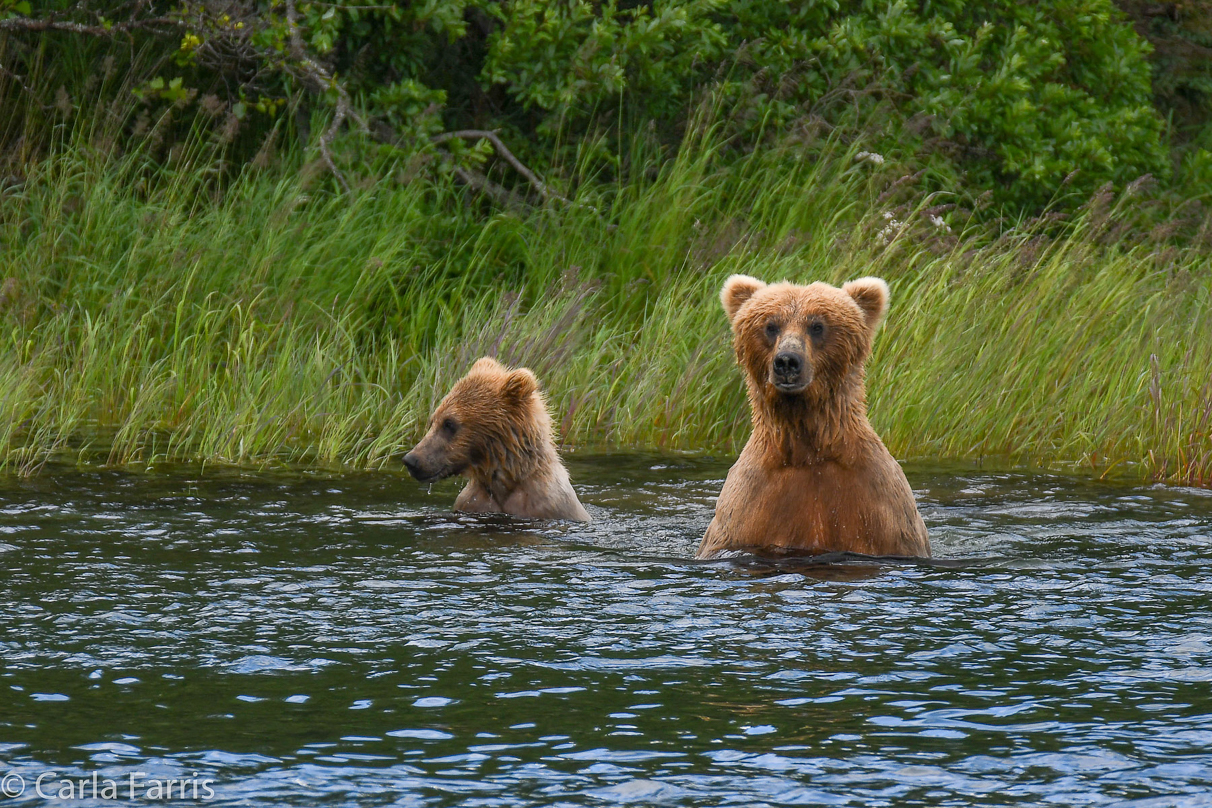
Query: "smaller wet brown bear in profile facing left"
404 356 589 522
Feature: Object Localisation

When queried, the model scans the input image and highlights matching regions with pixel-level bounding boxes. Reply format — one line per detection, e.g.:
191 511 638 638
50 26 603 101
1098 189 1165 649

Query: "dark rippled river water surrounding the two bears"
0 455 1212 807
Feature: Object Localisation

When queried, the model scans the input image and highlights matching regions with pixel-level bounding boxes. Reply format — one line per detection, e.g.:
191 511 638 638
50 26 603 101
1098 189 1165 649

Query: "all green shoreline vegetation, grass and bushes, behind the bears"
0 0 1212 486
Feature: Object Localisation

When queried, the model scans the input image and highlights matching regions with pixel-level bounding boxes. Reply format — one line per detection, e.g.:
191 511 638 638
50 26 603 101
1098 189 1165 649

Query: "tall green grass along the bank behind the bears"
0 135 1212 485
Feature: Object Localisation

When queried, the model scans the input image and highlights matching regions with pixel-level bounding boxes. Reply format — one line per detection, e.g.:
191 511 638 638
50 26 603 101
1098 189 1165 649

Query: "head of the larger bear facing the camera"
720 275 888 400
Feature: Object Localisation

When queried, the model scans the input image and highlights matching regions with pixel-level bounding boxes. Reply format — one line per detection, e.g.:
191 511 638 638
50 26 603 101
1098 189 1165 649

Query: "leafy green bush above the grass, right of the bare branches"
481 0 1167 207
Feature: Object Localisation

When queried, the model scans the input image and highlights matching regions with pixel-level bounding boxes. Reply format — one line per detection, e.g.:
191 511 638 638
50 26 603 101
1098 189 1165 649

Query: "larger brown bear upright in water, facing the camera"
698 275 930 558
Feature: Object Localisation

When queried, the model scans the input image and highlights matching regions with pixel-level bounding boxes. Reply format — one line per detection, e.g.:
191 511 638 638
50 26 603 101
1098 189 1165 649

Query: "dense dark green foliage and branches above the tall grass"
0 0 1192 210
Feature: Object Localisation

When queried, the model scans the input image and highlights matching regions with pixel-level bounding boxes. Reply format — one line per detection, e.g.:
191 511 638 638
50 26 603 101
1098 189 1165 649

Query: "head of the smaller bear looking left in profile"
404 356 550 482
